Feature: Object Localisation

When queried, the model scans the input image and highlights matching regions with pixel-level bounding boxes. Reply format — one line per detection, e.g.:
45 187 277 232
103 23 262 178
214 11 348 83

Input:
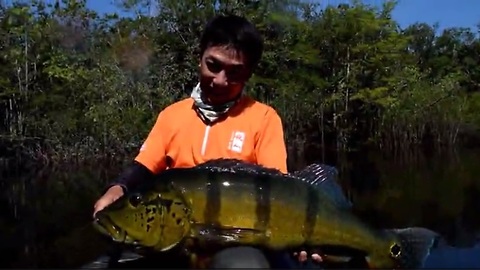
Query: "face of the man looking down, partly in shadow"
200 46 251 105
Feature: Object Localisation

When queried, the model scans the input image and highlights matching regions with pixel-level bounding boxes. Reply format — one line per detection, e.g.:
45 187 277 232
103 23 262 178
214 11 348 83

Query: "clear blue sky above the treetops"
87 0 480 31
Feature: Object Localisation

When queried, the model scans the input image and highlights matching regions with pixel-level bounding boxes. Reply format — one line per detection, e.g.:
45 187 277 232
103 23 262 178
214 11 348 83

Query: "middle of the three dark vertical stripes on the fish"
253 175 271 239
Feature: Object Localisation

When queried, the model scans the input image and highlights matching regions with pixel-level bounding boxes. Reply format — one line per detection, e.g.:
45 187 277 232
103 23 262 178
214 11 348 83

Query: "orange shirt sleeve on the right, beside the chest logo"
255 108 287 173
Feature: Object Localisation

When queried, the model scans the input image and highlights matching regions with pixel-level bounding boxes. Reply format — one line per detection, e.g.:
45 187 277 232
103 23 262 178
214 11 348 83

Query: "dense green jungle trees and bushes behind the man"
0 0 480 169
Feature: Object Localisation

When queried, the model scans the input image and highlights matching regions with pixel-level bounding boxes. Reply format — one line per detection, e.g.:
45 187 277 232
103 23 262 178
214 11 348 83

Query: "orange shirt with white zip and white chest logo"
135 96 287 173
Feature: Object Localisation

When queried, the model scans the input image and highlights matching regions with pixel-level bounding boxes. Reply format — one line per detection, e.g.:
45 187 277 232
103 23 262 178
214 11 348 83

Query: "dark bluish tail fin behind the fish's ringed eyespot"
387 227 442 269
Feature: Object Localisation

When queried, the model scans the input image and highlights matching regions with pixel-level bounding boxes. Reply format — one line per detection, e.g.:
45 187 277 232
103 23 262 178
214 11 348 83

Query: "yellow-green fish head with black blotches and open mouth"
94 186 190 250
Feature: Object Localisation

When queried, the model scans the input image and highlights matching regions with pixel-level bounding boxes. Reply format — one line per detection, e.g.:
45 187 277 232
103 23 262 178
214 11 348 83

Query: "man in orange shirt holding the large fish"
94 16 320 267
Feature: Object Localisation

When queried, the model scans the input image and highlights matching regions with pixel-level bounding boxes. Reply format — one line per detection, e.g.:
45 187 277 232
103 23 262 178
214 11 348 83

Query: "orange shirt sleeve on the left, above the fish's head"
135 111 171 174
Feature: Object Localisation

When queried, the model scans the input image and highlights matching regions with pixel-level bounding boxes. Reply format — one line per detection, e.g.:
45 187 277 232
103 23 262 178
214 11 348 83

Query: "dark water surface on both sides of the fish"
0 150 480 268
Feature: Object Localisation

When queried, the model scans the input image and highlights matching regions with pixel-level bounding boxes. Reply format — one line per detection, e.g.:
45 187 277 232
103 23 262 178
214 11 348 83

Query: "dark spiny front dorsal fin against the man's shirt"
194 158 283 175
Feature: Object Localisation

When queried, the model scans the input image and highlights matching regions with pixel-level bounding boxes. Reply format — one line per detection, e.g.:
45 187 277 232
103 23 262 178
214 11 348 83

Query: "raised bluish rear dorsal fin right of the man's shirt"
292 163 353 209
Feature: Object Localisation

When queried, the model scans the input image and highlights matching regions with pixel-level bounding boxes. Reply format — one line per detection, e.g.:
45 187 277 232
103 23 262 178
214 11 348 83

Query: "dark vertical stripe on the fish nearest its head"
203 171 222 224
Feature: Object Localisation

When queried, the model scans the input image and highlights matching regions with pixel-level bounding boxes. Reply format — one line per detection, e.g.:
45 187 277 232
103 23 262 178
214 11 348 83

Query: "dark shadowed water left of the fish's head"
0 162 118 268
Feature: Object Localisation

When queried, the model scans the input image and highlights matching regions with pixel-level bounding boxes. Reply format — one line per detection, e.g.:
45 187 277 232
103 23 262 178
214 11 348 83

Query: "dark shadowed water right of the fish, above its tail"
341 148 480 247
